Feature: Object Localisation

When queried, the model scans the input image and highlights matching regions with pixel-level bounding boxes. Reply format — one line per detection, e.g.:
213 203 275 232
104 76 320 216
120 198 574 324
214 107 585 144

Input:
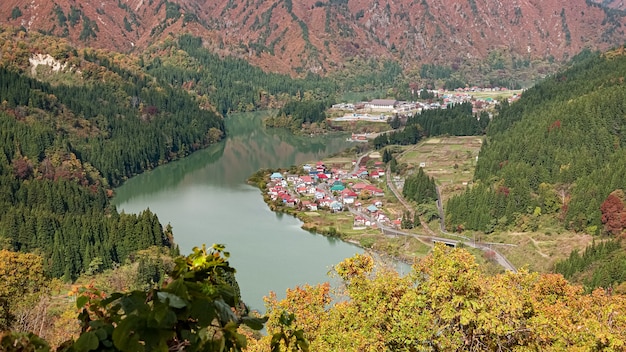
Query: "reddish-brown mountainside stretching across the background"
0 0 626 74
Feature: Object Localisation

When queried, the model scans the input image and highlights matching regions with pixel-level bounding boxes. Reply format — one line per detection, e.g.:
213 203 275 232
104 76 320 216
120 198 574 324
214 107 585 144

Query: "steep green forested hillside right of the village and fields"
446 48 626 234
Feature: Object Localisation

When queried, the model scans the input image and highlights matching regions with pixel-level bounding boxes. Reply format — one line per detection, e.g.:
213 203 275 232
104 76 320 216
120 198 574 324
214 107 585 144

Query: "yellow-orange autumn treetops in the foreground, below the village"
250 246 626 351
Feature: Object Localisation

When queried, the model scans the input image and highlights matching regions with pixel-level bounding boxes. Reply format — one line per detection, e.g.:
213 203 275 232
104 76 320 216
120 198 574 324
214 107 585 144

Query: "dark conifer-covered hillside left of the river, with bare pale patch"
0 31 229 280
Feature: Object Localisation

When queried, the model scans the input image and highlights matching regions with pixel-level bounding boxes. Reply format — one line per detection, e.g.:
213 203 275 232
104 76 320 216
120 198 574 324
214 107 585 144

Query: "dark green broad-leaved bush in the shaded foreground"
0 245 264 352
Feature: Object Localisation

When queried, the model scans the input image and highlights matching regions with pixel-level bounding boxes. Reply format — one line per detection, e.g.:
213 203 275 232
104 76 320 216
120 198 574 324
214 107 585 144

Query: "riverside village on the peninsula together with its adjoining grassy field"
249 136 515 271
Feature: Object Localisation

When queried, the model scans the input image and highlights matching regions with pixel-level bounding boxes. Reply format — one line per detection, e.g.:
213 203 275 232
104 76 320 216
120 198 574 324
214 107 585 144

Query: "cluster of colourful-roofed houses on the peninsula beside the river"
266 161 399 228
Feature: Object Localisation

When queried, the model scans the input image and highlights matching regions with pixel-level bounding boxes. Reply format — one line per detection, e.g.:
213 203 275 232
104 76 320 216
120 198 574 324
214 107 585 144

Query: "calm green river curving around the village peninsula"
113 113 362 311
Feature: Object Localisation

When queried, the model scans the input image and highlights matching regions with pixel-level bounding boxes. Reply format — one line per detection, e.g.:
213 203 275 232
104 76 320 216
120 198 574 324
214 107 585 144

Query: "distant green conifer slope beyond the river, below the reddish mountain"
142 34 338 114
